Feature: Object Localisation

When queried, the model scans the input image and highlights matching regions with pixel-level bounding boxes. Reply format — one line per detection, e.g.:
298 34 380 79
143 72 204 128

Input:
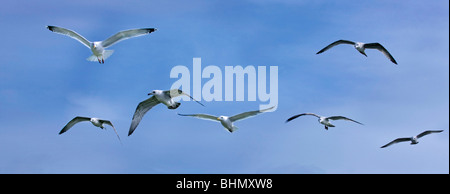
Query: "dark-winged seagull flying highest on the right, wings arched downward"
316 40 397 64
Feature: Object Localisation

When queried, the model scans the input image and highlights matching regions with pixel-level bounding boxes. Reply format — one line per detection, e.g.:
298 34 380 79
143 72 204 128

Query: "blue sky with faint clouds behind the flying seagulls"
0 0 449 173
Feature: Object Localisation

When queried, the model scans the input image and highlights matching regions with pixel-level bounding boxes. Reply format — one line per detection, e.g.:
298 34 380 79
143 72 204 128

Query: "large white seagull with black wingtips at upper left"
47 26 156 63
